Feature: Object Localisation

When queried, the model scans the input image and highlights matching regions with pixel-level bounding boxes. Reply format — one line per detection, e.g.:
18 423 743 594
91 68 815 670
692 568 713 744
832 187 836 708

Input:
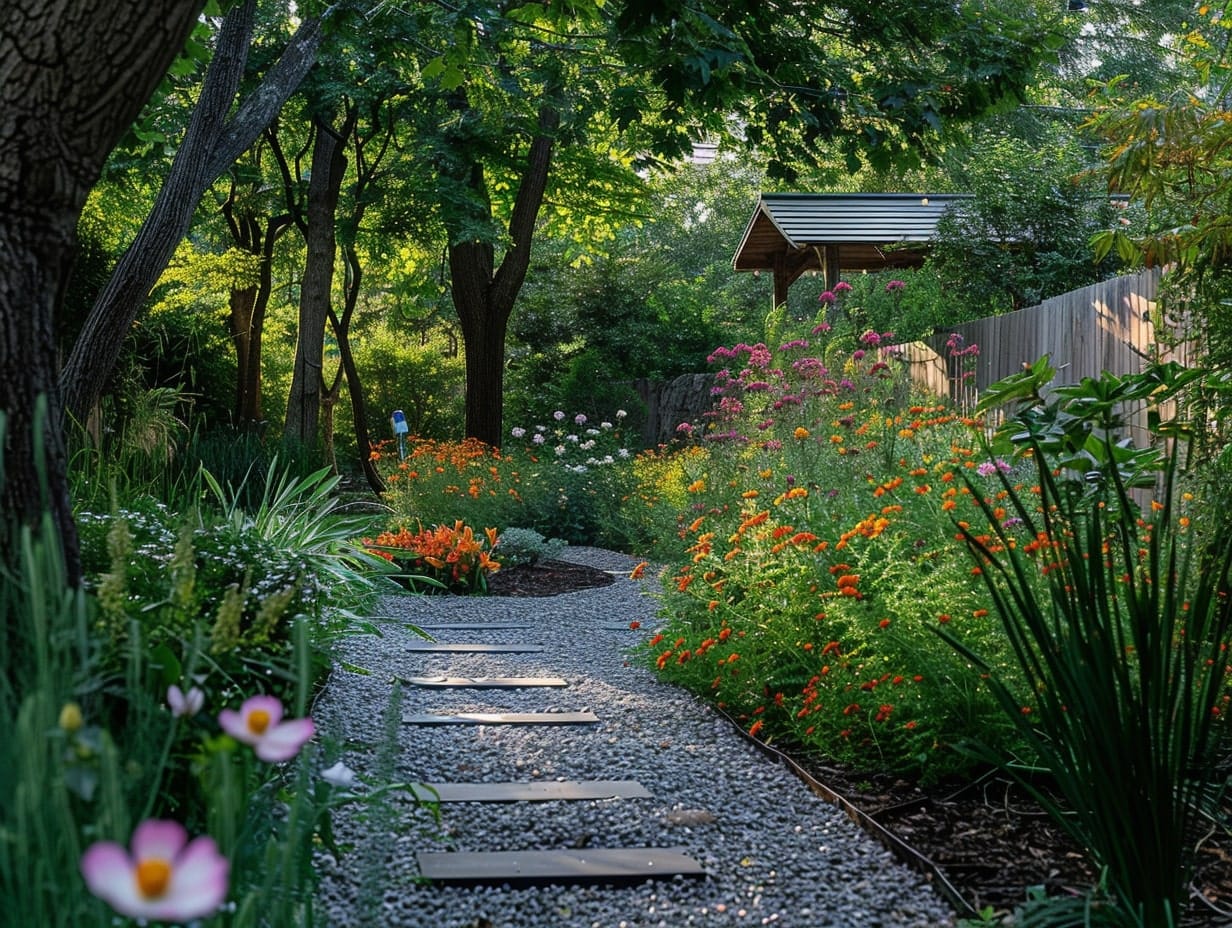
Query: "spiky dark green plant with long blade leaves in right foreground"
942 364 1232 928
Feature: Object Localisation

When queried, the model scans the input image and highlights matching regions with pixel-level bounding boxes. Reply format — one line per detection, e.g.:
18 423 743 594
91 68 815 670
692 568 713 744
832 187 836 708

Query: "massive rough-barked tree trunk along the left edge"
0 0 202 579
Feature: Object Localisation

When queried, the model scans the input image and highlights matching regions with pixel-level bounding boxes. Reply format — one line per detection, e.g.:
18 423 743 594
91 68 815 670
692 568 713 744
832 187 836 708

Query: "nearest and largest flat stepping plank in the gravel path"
415 848 706 886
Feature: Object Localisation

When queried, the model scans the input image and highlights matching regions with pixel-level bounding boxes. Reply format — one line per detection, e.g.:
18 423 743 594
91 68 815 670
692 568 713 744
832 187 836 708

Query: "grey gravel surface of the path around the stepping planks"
313 547 955 928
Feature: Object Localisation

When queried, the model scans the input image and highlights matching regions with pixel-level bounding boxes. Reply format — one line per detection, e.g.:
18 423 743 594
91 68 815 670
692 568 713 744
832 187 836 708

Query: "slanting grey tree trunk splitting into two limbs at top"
60 0 320 419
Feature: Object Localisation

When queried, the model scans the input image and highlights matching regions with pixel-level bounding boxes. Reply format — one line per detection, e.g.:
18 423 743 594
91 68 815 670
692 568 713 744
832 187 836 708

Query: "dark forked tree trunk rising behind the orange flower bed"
448 105 561 447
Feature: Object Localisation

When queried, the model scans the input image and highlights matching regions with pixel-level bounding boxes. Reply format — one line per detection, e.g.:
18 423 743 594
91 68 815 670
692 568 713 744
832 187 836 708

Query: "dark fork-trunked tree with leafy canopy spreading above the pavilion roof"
389 0 1062 444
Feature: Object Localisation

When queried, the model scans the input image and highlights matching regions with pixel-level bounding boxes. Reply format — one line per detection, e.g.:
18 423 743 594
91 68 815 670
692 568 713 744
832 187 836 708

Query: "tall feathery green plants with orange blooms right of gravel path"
637 324 1013 779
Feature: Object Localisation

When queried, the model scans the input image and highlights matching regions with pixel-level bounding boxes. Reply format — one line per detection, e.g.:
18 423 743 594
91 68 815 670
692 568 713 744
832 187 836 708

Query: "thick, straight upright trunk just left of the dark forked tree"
282 111 355 446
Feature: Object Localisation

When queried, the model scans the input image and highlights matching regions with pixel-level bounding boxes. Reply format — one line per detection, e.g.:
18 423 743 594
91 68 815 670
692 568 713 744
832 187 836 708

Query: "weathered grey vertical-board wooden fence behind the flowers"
898 271 1188 444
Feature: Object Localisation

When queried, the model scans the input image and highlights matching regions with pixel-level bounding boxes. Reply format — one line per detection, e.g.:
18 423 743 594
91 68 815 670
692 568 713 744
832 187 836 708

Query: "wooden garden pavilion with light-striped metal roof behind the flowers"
732 193 972 306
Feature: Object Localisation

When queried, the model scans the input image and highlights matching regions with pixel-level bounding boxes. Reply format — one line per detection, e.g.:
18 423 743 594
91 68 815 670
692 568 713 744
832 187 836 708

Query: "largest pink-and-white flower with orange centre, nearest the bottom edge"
81 818 230 922
